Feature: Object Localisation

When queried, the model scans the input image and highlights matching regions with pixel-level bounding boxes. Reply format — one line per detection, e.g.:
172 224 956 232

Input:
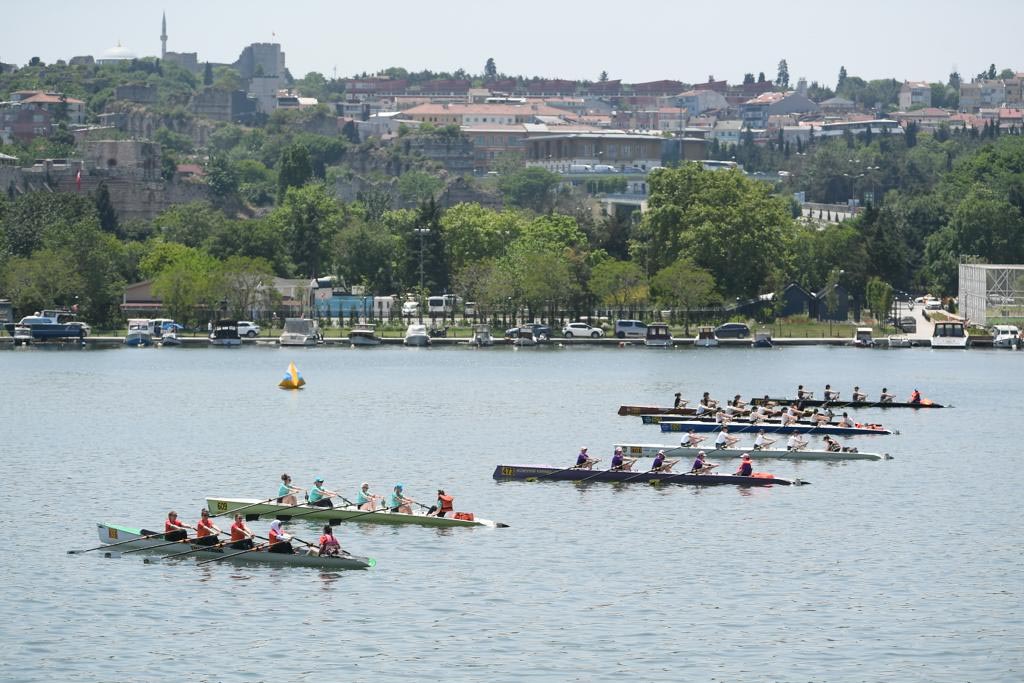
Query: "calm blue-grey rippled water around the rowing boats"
0 348 1024 682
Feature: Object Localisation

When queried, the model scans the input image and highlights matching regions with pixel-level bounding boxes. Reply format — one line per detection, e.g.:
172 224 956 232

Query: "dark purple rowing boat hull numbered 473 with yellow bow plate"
494 465 809 486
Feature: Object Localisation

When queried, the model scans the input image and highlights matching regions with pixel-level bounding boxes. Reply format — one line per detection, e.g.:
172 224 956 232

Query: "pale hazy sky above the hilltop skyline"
0 0 1024 86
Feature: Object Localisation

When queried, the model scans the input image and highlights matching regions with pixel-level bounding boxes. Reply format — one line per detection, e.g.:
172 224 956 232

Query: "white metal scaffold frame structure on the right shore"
958 263 1024 327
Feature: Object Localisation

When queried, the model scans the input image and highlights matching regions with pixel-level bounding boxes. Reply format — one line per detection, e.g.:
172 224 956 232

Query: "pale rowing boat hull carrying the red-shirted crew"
96 524 377 569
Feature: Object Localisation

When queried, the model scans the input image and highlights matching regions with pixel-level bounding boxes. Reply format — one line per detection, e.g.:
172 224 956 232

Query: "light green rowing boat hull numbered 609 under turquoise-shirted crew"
206 498 508 527
